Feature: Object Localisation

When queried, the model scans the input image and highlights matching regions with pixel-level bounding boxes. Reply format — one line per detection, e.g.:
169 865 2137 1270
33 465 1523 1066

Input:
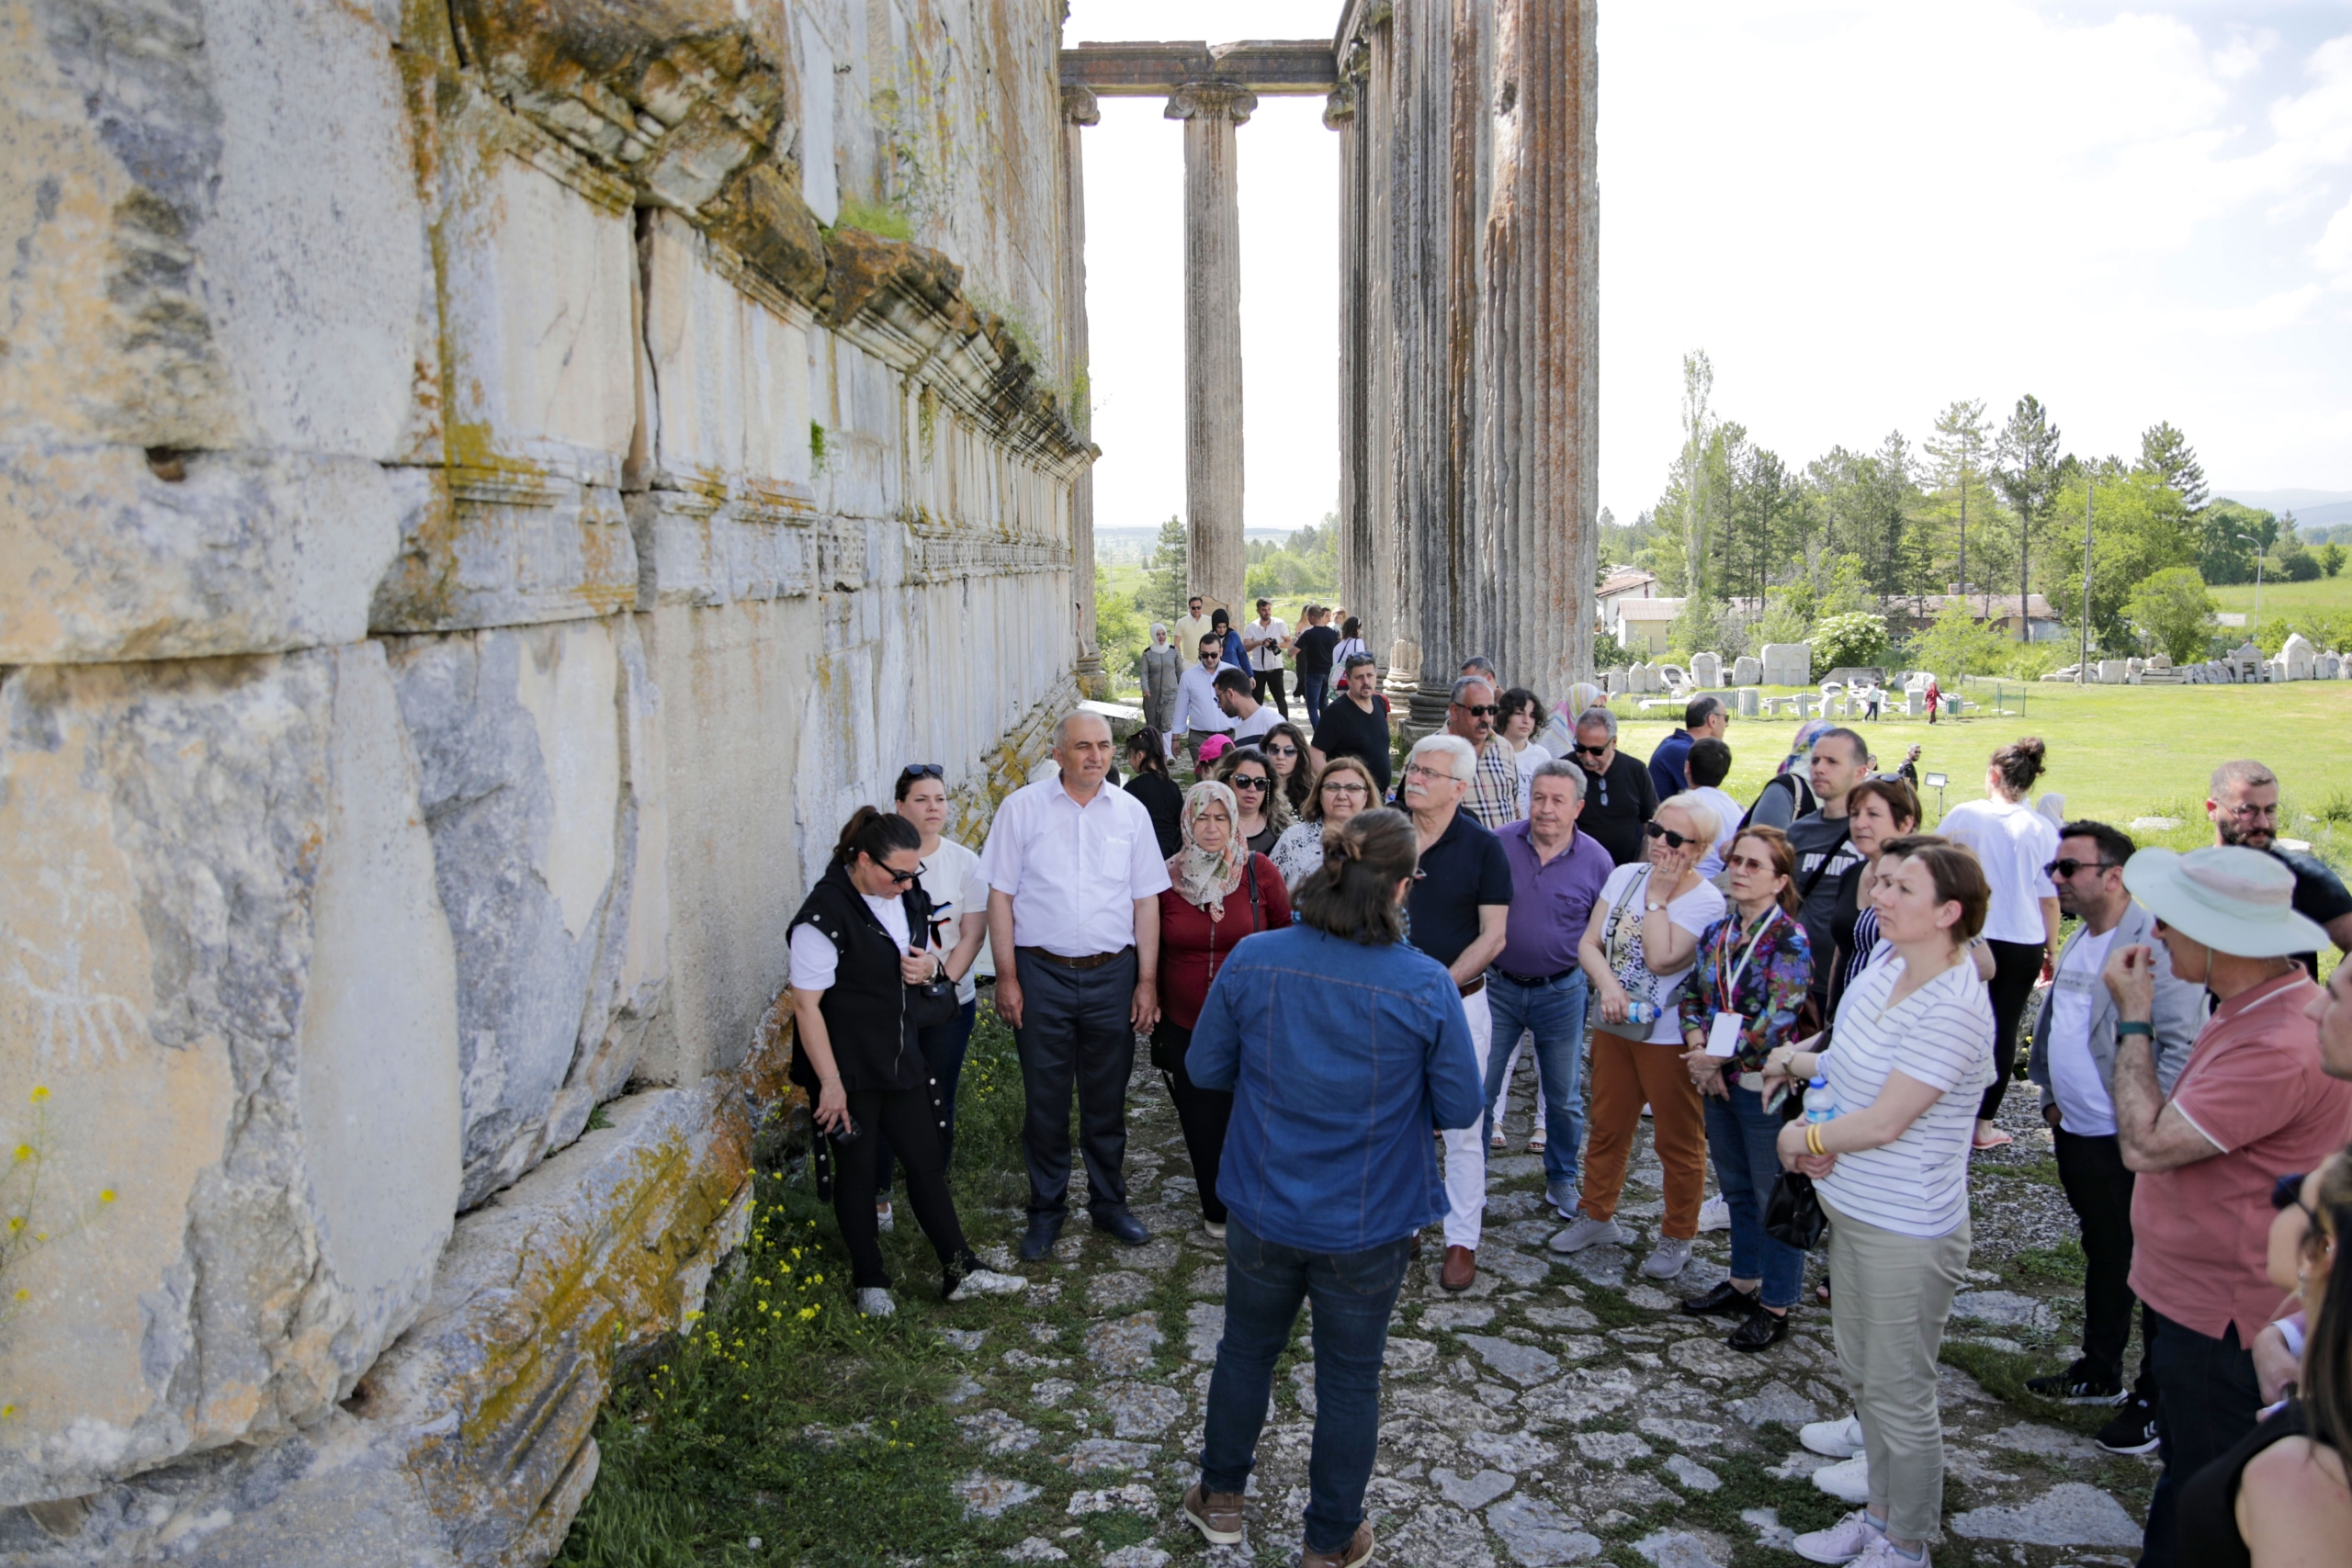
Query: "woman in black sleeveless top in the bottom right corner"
2180 1149 2352 1568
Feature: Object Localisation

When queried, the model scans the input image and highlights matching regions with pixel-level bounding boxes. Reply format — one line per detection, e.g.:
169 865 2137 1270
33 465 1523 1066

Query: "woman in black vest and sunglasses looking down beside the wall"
788 807 1028 1316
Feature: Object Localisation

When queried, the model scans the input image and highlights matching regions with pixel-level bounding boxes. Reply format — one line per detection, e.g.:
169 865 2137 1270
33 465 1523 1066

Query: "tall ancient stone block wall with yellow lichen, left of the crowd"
0 0 1091 1563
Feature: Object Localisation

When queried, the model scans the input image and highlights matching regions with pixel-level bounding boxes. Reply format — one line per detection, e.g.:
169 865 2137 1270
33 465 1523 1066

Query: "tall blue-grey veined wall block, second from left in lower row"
393 618 665 1206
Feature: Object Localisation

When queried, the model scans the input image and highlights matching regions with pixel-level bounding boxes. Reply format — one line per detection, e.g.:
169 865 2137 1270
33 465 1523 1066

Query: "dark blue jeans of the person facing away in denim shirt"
1200 1220 1414 1551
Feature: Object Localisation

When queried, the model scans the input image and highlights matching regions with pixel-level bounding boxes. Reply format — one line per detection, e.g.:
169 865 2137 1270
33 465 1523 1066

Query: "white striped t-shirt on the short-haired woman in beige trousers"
1815 952 1992 1236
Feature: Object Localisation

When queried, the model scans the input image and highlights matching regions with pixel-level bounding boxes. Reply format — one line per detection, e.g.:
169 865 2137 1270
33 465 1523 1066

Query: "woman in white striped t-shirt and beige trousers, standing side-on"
1764 840 1992 1563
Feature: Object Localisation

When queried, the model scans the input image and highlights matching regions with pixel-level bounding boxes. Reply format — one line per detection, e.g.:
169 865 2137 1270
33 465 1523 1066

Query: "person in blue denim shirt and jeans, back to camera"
1183 808 1487 1568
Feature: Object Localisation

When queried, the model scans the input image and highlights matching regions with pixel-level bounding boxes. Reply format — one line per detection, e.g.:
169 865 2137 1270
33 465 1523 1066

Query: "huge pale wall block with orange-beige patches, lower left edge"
0 644 458 1502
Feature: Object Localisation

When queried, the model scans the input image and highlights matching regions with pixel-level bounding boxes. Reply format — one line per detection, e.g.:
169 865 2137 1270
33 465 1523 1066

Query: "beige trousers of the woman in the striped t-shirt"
1823 1201 1969 1540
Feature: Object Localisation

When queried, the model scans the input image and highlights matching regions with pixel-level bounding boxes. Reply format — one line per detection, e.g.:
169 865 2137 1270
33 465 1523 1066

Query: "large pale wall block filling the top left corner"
0 0 433 458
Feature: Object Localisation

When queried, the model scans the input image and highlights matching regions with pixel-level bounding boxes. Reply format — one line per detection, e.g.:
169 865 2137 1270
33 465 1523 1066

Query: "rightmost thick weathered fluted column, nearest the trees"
1465 0 1600 698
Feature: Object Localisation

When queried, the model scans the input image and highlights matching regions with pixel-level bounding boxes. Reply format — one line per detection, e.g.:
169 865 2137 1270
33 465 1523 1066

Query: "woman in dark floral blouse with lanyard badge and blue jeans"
1677 828 1814 1352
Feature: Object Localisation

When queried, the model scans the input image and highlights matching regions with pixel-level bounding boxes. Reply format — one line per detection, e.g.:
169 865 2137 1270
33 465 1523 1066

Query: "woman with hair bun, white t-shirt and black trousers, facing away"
1938 736 2058 1149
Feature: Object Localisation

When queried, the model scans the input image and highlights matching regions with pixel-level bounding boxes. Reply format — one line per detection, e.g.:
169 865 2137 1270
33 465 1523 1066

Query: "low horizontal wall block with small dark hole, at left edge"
0 444 425 663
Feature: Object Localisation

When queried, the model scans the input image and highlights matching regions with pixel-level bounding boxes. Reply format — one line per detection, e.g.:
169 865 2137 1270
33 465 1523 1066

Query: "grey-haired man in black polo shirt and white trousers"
1399 736 1510 1291
